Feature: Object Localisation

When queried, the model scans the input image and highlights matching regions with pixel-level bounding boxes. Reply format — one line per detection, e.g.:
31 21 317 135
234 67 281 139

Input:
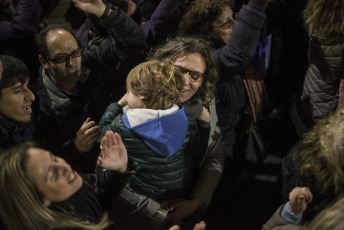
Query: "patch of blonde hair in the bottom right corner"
307 198 344 230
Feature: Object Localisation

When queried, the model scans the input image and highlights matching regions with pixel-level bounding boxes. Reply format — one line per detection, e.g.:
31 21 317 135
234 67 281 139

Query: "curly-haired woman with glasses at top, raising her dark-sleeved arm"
178 0 268 161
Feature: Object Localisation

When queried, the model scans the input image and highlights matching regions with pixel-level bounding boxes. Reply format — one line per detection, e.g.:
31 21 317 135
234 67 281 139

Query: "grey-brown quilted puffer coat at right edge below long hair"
302 32 344 123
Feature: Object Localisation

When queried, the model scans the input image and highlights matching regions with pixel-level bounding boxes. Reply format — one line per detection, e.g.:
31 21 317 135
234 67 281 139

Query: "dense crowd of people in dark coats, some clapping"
0 0 344 230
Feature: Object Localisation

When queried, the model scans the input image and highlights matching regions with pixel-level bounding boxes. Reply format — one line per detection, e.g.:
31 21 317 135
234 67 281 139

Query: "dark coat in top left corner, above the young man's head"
0 0 58 79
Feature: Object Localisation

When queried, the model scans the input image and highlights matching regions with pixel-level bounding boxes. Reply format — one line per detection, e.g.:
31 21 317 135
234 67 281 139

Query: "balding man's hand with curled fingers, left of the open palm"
74 117 100 153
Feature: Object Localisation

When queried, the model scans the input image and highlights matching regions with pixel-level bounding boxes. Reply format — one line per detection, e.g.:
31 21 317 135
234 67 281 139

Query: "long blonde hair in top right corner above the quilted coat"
303 0 344 39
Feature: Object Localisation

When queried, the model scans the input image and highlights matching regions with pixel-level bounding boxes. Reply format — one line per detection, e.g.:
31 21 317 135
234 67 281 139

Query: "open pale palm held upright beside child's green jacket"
97 131 128 172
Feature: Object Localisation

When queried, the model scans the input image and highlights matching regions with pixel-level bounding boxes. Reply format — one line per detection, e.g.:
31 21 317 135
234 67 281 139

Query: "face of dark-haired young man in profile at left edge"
0 80 35 123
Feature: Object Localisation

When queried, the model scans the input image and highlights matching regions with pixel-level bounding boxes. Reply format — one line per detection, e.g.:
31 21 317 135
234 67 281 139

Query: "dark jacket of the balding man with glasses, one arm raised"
34 5 146 173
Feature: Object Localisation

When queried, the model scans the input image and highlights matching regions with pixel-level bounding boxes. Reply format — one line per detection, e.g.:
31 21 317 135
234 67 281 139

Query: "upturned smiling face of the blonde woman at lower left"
26 148 83 203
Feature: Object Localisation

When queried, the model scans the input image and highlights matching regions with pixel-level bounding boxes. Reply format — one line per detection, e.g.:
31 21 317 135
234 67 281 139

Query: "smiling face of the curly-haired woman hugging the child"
174 53 206 103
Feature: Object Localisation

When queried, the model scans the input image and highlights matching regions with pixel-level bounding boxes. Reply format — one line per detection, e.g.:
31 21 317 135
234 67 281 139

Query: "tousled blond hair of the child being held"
127 59 185 109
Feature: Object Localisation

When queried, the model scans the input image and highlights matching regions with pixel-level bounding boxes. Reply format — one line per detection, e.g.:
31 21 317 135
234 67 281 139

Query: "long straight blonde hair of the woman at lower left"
0 142 109 230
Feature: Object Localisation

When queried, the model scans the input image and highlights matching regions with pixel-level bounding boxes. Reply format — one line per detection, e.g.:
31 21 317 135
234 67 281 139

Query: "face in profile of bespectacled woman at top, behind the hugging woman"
211 6 234 44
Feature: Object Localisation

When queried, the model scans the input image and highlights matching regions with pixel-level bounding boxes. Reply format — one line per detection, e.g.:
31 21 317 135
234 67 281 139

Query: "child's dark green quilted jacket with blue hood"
99 103 210 200
